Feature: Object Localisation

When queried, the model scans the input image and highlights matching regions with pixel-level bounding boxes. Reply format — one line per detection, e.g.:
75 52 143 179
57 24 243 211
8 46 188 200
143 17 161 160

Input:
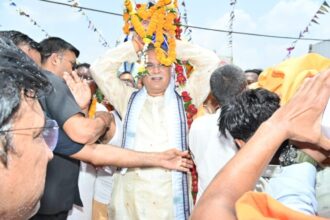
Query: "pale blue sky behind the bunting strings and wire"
0 0 330 69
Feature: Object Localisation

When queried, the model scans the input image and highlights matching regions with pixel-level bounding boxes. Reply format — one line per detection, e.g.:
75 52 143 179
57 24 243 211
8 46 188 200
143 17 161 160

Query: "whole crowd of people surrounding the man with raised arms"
0 26 330 220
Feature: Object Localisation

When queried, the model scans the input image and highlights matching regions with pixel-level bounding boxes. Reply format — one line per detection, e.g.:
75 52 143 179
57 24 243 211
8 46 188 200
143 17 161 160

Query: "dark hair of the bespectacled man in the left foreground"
0 37 52 166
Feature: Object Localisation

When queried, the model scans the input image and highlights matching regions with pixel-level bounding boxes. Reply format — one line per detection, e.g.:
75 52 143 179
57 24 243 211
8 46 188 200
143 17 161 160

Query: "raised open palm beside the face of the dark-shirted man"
63 71 92 110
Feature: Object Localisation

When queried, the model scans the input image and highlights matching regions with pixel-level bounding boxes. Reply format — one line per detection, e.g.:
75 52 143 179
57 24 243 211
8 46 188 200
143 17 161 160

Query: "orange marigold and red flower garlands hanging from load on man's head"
123 0 198 203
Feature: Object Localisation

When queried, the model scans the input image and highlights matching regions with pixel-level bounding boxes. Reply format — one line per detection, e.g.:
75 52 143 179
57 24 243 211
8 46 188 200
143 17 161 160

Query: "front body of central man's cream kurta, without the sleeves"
109 96 173 220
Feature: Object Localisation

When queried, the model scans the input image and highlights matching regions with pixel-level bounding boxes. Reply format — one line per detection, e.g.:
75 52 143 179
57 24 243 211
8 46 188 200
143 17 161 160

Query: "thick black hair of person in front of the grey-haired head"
219 88 280 142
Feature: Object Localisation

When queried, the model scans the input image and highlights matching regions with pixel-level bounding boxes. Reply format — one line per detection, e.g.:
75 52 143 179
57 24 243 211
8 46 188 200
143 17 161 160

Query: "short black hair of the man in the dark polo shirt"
40 37 80 63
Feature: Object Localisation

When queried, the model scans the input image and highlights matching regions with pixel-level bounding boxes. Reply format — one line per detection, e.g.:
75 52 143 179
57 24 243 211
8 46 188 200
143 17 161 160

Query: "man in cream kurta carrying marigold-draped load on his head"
92 0 219 220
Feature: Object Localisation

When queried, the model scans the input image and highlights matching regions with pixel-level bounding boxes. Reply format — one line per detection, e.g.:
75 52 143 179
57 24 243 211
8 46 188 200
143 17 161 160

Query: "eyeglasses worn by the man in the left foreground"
0 119 59 151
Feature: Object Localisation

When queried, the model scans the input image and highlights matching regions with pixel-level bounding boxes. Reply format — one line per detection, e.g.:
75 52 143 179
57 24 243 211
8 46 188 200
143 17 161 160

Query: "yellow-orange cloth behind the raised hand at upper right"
249 53 330 105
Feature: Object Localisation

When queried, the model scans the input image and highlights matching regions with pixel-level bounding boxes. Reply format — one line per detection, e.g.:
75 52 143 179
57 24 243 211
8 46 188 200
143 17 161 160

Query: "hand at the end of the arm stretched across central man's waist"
160 149 193 172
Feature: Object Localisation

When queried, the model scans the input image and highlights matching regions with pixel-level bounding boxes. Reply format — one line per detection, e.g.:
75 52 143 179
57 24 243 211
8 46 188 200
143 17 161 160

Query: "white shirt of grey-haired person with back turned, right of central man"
189 109 237 200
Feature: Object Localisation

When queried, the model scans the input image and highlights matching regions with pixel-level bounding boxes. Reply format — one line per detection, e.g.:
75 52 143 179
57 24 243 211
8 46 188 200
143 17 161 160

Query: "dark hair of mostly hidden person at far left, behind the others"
0 30 40 51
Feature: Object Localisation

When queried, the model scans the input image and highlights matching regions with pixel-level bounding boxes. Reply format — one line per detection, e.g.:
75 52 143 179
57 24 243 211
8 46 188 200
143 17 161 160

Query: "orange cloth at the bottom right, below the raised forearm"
236 192 325 220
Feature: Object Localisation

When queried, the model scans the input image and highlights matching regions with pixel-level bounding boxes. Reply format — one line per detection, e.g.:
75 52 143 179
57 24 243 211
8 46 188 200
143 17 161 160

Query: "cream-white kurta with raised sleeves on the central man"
91 41 219 220
